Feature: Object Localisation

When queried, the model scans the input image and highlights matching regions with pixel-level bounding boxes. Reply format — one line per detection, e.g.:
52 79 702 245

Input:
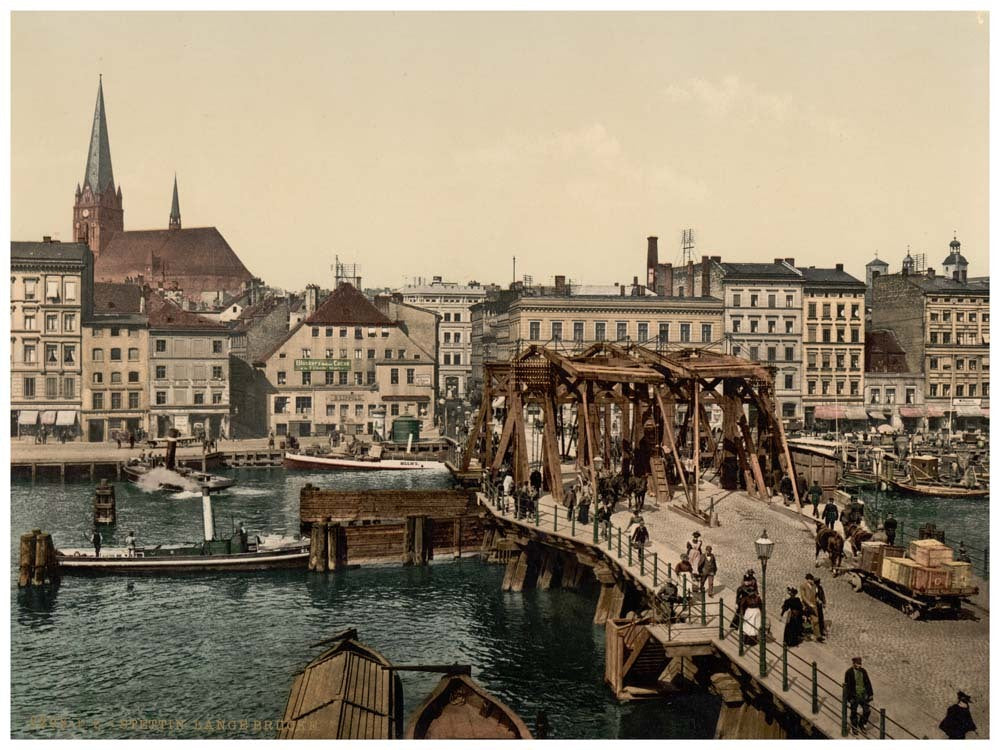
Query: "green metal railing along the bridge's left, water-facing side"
482 482 919 739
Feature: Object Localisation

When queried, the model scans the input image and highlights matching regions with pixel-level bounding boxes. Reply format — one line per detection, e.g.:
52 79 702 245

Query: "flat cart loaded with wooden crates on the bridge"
846 542 979 620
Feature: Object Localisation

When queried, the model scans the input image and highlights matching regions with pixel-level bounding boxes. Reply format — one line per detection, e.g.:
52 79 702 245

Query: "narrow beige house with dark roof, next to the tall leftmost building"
81 283 149 443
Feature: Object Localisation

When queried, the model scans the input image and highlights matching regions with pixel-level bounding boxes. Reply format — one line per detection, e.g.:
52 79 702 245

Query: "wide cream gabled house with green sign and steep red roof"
254 283 436 437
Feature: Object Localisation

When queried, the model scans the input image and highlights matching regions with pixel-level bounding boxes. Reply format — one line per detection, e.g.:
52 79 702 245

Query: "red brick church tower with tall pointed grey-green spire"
73 79 125 258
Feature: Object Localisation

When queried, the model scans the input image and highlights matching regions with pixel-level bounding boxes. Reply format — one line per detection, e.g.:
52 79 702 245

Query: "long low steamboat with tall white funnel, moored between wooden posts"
56 490 309 575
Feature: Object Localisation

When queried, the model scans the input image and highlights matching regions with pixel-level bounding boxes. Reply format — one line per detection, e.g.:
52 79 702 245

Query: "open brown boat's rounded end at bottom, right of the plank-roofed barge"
406 674 531 740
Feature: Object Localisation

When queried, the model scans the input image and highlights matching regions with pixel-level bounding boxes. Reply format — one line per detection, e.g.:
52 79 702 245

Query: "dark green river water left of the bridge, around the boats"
11 469 718 739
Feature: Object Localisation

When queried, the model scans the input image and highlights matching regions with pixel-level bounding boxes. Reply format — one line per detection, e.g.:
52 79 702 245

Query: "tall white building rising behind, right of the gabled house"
399 276 486 399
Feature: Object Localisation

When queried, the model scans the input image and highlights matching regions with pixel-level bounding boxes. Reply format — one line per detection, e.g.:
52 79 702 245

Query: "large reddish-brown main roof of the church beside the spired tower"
94 227 252 295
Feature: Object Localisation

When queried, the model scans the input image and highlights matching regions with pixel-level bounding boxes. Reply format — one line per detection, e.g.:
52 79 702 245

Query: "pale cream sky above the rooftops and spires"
11 12 989 289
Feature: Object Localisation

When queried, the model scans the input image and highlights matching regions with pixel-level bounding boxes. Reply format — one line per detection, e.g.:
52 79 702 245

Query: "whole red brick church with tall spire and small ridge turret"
73 81 253 306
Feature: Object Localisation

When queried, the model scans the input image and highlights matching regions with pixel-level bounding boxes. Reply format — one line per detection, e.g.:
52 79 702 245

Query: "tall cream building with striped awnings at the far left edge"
10 237 94 439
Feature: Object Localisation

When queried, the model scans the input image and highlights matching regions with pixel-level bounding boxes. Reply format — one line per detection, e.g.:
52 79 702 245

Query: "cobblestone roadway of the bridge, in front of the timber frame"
614 484 989 738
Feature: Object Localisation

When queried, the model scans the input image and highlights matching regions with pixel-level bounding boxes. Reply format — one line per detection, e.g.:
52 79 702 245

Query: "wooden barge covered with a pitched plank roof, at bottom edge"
278 628 403 740
